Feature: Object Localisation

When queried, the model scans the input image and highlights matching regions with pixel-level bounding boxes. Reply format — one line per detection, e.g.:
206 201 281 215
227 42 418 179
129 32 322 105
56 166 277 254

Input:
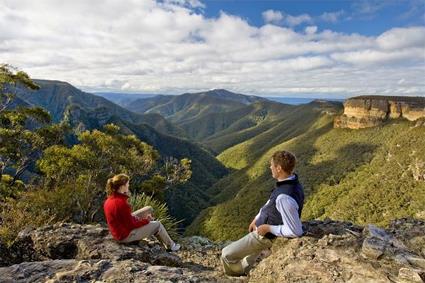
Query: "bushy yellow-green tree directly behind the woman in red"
37 125 158 222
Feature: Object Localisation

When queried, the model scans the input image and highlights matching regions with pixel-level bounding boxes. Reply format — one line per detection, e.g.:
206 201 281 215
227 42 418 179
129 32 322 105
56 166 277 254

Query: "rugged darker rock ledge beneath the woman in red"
0 223 232 282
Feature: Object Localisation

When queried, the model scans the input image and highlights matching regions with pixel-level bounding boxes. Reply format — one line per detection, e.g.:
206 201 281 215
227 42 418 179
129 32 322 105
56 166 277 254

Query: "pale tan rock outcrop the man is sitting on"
250 219 425 282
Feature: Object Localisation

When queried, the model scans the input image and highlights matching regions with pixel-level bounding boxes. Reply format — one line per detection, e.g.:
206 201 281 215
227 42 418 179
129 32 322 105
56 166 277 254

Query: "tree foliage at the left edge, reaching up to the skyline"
0 65 67 186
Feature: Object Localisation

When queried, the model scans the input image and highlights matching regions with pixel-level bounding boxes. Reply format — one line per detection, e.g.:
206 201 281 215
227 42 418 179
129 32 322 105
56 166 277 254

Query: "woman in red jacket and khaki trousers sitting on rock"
103 174 180 251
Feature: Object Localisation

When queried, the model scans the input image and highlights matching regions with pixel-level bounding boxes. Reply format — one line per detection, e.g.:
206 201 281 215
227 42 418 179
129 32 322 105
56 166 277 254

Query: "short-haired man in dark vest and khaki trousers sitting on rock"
221 151 304 276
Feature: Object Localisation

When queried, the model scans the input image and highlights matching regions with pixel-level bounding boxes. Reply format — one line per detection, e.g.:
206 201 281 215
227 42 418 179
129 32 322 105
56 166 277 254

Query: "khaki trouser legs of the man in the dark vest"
221 232 272 276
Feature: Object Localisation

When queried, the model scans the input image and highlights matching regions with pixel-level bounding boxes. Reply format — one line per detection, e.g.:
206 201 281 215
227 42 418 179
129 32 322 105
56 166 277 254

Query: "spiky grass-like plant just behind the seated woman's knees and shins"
129 193 182 238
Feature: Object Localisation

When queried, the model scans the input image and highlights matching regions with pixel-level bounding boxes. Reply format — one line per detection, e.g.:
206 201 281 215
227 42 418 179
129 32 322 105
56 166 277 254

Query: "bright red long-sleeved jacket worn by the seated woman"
103 193 149 241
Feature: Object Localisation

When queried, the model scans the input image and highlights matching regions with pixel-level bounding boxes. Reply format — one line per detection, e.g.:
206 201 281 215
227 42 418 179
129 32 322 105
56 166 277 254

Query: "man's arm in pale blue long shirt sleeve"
270 194 303 238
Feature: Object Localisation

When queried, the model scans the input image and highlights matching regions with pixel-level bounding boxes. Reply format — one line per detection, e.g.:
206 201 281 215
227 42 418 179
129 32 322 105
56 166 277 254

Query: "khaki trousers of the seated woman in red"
120 206 174 248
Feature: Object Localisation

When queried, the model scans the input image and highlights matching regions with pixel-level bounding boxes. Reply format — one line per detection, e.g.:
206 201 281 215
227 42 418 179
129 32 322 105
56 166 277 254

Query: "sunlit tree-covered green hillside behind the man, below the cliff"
188 105 425 240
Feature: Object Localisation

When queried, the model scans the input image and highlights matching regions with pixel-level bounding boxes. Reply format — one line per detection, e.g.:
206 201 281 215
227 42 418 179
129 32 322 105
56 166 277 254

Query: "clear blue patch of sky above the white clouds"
203 0 425 35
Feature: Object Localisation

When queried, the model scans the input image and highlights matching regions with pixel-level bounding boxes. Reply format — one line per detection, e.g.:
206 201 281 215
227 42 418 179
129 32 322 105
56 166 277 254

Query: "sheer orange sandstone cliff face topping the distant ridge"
334 96 425 129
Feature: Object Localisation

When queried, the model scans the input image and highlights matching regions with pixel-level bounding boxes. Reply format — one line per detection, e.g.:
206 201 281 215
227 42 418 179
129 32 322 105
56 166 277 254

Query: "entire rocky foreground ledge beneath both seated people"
0 219 425 282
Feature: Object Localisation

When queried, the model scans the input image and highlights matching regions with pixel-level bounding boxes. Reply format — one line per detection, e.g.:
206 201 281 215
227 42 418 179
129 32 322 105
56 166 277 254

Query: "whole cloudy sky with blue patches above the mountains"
0 0 425 97
